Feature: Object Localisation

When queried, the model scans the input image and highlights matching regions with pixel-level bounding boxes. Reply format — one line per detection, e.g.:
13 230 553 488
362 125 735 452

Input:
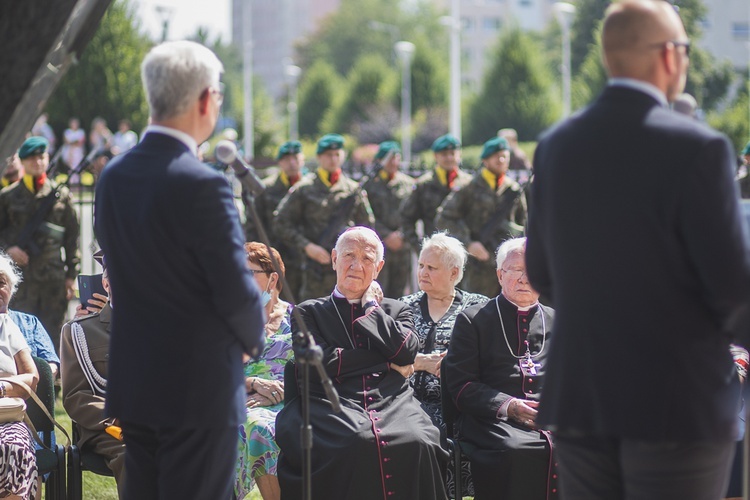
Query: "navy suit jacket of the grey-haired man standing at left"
95 132 265 428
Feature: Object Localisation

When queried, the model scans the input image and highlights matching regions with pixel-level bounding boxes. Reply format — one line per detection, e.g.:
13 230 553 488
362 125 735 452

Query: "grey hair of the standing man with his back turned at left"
141 40 224 121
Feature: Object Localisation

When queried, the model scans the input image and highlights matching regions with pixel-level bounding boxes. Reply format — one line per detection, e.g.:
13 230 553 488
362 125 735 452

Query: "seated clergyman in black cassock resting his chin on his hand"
276 227 447 500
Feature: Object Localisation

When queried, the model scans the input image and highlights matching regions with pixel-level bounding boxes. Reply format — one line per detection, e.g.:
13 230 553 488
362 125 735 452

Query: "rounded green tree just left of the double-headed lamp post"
322 54 399 133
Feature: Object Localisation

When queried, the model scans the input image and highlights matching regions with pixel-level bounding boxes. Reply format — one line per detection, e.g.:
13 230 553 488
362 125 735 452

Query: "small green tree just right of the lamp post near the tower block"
298 60 343 138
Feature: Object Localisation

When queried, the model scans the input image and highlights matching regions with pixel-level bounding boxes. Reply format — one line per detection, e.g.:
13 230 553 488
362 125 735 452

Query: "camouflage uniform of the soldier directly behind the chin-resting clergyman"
276 173 375 302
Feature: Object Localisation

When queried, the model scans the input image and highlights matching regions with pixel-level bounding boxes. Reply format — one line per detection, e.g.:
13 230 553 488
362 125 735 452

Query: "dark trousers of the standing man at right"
555 434 735 500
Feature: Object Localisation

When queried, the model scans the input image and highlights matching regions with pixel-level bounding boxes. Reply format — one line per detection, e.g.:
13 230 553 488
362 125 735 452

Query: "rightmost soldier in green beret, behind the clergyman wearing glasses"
435 137 526 297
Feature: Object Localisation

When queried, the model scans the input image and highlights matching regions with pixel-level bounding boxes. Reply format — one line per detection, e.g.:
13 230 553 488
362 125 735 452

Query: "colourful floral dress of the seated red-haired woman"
234 306 294 500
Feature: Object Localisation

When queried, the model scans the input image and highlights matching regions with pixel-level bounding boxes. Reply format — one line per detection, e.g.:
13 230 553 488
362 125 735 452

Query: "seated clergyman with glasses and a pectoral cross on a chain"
442 238 557 500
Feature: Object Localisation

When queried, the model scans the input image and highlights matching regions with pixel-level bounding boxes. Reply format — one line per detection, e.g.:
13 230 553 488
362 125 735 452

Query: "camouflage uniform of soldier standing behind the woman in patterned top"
401 167 471 252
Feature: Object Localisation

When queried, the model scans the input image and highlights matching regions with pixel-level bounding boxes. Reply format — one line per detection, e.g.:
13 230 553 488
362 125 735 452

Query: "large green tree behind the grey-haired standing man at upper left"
45 0 151 137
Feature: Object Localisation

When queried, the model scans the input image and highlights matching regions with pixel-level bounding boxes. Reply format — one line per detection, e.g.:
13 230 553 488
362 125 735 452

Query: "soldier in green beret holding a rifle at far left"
0 136 80 354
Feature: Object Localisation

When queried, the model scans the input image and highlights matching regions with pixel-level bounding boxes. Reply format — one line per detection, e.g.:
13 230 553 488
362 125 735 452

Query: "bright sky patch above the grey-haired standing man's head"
131 0 232 42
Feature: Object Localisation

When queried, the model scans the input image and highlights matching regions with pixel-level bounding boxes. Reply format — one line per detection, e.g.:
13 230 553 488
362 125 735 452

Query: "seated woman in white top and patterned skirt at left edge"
0 253 39 499
